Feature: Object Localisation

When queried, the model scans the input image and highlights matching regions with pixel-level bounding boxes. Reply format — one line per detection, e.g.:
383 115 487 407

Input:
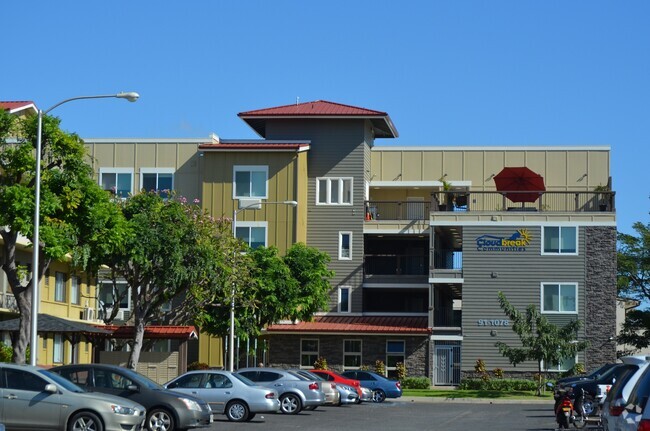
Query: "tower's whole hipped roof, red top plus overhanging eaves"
237 100 398 138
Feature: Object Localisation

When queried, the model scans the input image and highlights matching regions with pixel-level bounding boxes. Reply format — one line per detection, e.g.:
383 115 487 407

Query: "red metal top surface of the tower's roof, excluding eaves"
237 100 388 117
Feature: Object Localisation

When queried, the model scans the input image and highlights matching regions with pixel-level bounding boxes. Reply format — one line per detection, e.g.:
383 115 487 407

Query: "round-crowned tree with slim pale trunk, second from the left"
93 192 235 369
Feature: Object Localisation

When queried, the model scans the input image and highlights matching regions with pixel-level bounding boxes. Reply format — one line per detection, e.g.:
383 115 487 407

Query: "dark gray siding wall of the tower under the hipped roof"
266 119 369 312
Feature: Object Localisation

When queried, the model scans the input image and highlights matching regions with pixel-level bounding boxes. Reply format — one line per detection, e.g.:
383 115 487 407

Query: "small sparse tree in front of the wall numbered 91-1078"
495 292 589 395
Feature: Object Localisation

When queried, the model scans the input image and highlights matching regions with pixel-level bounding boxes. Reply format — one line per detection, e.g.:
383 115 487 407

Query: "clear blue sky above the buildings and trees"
0 0 650 233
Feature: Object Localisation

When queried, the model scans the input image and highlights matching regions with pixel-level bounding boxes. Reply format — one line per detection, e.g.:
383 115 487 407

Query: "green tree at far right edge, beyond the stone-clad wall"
617 222 650 353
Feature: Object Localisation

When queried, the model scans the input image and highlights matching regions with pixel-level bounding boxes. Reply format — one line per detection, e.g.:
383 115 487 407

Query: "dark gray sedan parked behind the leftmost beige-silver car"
50 364 212 431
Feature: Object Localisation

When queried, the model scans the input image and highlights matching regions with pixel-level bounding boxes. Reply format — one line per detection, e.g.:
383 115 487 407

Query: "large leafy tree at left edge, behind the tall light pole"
0 110 120 363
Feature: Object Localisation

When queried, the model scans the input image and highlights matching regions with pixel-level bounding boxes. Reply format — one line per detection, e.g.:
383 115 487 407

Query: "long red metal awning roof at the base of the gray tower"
266 316 429 335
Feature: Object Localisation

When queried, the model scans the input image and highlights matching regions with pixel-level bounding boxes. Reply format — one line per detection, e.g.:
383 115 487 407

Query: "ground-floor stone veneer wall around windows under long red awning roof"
268 334 430 377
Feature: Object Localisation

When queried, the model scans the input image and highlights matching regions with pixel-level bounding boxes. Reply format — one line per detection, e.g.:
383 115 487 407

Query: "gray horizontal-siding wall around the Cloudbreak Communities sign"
462 226 588 371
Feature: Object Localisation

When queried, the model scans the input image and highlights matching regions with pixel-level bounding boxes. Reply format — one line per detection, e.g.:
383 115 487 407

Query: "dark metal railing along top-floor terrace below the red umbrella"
365 191 616 221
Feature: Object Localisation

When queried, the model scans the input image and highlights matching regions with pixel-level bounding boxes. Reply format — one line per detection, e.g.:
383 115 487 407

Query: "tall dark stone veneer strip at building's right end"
583 226 616 370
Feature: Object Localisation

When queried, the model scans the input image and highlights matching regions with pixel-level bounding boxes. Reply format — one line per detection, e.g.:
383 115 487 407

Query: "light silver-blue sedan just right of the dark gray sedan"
165 370 280 422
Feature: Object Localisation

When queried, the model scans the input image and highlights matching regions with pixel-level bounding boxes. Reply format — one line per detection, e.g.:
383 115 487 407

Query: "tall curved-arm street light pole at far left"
29 92 140 365
